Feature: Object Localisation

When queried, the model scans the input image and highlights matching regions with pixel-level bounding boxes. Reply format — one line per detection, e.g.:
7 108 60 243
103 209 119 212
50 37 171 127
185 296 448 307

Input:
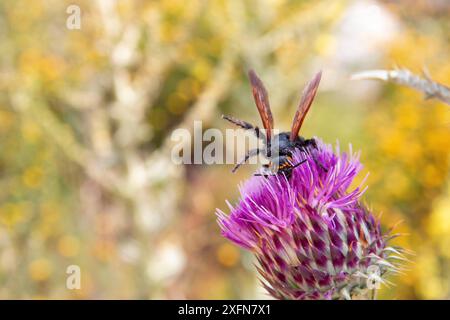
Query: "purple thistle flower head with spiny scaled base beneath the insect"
217 138 402 299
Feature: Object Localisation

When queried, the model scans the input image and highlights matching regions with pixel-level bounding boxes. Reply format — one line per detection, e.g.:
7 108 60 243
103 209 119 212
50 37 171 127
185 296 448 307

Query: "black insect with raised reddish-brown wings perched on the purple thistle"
222 70 322 178
